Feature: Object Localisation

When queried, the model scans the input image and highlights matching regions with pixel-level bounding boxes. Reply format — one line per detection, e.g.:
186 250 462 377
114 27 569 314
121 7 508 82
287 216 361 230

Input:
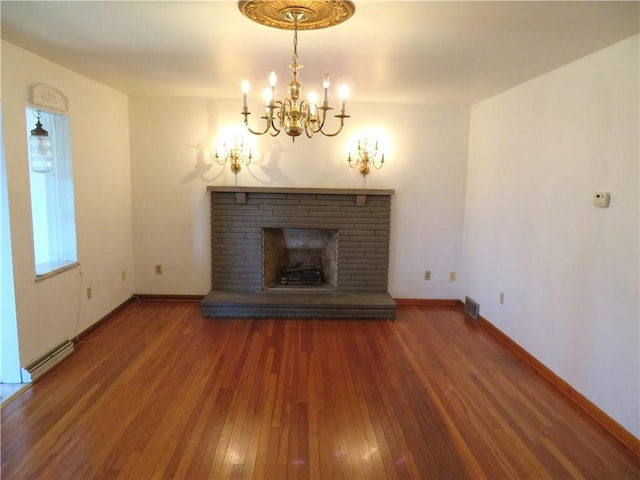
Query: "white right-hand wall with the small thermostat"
462 36 640 436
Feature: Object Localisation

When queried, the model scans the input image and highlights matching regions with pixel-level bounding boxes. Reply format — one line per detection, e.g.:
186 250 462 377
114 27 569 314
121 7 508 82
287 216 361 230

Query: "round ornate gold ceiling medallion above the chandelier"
238 0 356 30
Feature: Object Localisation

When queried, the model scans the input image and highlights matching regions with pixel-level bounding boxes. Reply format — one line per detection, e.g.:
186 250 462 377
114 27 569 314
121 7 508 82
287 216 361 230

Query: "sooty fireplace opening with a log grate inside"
262 228 338 289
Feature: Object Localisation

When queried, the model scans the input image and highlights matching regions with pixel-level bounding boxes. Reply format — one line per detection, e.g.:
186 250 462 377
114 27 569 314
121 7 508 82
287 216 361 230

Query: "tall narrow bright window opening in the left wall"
27 107 78 280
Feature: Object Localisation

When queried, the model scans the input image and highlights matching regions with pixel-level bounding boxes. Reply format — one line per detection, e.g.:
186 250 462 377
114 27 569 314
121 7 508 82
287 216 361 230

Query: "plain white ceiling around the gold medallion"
0 0 640 104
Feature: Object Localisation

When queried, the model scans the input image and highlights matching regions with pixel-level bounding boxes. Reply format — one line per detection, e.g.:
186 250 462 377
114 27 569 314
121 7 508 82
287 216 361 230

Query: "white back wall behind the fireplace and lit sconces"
129 95 469 299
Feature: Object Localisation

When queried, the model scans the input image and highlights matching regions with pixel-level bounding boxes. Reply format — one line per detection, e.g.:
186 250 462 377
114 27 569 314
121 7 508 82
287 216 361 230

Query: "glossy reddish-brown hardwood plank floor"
1 301 640 480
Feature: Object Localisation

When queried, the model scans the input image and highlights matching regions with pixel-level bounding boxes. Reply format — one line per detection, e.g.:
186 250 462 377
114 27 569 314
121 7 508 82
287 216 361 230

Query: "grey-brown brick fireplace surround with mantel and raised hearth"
202 187 395 319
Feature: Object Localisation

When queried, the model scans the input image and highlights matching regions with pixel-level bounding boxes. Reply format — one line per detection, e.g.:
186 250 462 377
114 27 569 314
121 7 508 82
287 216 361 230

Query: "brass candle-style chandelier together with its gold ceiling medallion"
238 0 355 141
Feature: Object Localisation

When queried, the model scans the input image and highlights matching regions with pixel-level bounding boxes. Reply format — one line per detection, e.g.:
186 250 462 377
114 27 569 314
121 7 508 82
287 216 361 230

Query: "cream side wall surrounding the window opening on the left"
2 42 134 366
